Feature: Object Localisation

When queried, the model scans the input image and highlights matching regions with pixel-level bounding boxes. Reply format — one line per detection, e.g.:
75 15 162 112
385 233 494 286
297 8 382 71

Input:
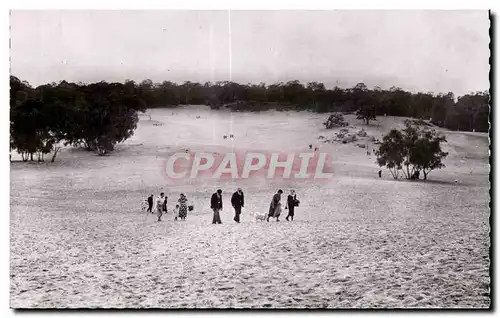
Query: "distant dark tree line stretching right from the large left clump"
123 80 490 132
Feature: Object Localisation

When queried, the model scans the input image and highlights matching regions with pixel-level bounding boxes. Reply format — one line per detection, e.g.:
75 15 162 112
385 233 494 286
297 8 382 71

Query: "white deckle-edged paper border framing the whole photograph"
0 0 500 317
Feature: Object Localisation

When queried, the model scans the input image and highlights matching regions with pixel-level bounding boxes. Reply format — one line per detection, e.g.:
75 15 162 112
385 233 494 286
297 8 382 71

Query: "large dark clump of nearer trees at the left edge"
10 76 147 161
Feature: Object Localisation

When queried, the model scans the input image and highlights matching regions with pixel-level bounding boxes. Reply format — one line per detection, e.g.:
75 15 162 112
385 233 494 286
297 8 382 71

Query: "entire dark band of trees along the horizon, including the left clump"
10 76 490 160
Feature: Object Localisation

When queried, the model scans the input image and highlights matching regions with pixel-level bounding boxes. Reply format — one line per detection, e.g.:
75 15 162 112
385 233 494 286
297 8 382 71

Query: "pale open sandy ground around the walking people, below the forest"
10 107 490 308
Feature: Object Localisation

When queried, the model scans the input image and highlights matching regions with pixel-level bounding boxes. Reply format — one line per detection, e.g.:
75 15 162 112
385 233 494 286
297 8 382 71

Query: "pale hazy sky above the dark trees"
11 11 489 95
